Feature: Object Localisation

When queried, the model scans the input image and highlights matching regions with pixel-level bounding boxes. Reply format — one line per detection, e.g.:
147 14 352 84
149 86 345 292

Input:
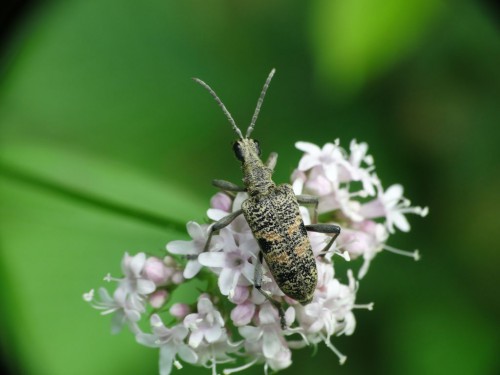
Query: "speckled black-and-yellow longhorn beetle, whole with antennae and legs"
193 69 340 329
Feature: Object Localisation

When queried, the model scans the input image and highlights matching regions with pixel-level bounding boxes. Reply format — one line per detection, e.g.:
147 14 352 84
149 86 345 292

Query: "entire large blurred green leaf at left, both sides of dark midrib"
0 143 207 374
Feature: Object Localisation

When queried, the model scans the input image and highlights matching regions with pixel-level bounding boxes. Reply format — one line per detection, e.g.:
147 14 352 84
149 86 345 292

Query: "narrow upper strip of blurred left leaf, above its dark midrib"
0 141 206 230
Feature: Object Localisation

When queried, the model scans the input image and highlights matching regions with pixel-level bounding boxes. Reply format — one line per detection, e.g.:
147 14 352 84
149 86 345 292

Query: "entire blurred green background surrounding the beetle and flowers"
0 0 500 375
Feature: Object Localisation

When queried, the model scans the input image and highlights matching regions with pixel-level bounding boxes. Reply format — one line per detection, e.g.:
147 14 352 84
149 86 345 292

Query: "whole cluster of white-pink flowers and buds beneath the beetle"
84 141 428 375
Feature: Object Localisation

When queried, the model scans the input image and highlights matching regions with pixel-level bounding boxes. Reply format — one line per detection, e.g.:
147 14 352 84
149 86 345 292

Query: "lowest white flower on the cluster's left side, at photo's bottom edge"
136 314 198 375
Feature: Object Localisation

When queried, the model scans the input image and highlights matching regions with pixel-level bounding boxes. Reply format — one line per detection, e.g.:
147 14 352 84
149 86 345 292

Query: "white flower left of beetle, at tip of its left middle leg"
167 221 222 279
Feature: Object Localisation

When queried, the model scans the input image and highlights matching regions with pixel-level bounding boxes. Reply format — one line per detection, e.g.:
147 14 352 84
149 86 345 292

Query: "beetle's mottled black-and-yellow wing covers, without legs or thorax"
242 185 318 304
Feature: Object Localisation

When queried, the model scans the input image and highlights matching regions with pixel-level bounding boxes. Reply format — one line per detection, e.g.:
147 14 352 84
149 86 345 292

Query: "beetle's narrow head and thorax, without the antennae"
235 138 276 196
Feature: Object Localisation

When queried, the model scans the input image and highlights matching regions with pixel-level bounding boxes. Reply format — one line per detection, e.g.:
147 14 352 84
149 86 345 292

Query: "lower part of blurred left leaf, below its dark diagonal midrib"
0 178 169 374
